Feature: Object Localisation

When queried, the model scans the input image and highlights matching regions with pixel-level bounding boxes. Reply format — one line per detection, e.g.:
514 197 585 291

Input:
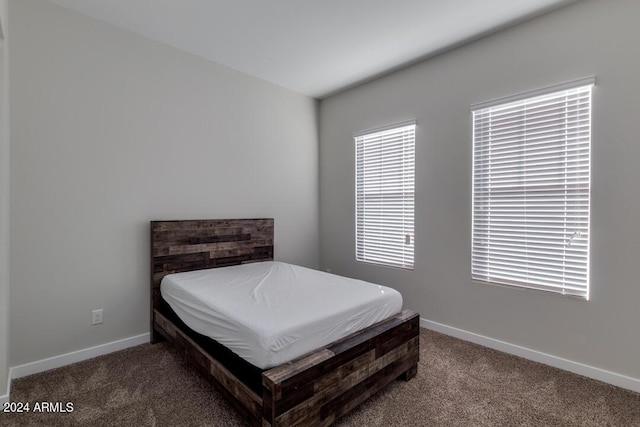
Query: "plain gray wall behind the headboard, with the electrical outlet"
9 0 319 366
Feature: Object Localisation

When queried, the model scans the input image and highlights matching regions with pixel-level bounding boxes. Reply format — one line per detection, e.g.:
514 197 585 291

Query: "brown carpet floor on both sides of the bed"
0 329 640 427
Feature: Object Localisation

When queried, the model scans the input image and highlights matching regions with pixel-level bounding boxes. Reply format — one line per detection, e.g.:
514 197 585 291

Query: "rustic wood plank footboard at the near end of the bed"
262 310 420 426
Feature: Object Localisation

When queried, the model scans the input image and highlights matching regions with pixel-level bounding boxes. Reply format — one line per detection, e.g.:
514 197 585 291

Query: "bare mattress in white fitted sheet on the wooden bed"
160 261 402 369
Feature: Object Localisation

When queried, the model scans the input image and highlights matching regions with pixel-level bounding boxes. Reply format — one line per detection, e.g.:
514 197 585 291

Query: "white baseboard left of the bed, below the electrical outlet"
0 333 150 403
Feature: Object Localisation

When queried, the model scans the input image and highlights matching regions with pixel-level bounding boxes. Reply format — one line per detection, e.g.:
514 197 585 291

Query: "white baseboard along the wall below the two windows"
420 318 640 393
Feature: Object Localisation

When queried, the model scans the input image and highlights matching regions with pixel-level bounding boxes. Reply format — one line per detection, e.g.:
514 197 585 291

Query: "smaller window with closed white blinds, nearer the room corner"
354 122 416 270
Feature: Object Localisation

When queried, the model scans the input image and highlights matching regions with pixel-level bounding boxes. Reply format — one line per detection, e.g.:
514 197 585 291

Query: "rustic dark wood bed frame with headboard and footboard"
151 218 419 426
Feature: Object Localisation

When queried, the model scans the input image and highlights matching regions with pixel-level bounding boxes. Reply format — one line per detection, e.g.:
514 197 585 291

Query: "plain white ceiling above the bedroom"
43 0 577 98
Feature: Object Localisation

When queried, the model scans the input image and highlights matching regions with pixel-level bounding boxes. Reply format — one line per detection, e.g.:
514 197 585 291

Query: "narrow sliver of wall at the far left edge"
0 0 9 397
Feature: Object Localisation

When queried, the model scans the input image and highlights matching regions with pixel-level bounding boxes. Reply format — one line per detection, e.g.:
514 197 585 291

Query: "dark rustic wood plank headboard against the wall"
151 218 273 342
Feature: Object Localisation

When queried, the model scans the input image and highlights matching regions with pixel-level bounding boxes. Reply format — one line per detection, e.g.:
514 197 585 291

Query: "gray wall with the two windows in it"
320 0 640 379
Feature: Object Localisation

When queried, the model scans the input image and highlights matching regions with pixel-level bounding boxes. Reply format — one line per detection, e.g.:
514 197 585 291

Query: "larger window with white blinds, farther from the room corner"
471 78 595 299
